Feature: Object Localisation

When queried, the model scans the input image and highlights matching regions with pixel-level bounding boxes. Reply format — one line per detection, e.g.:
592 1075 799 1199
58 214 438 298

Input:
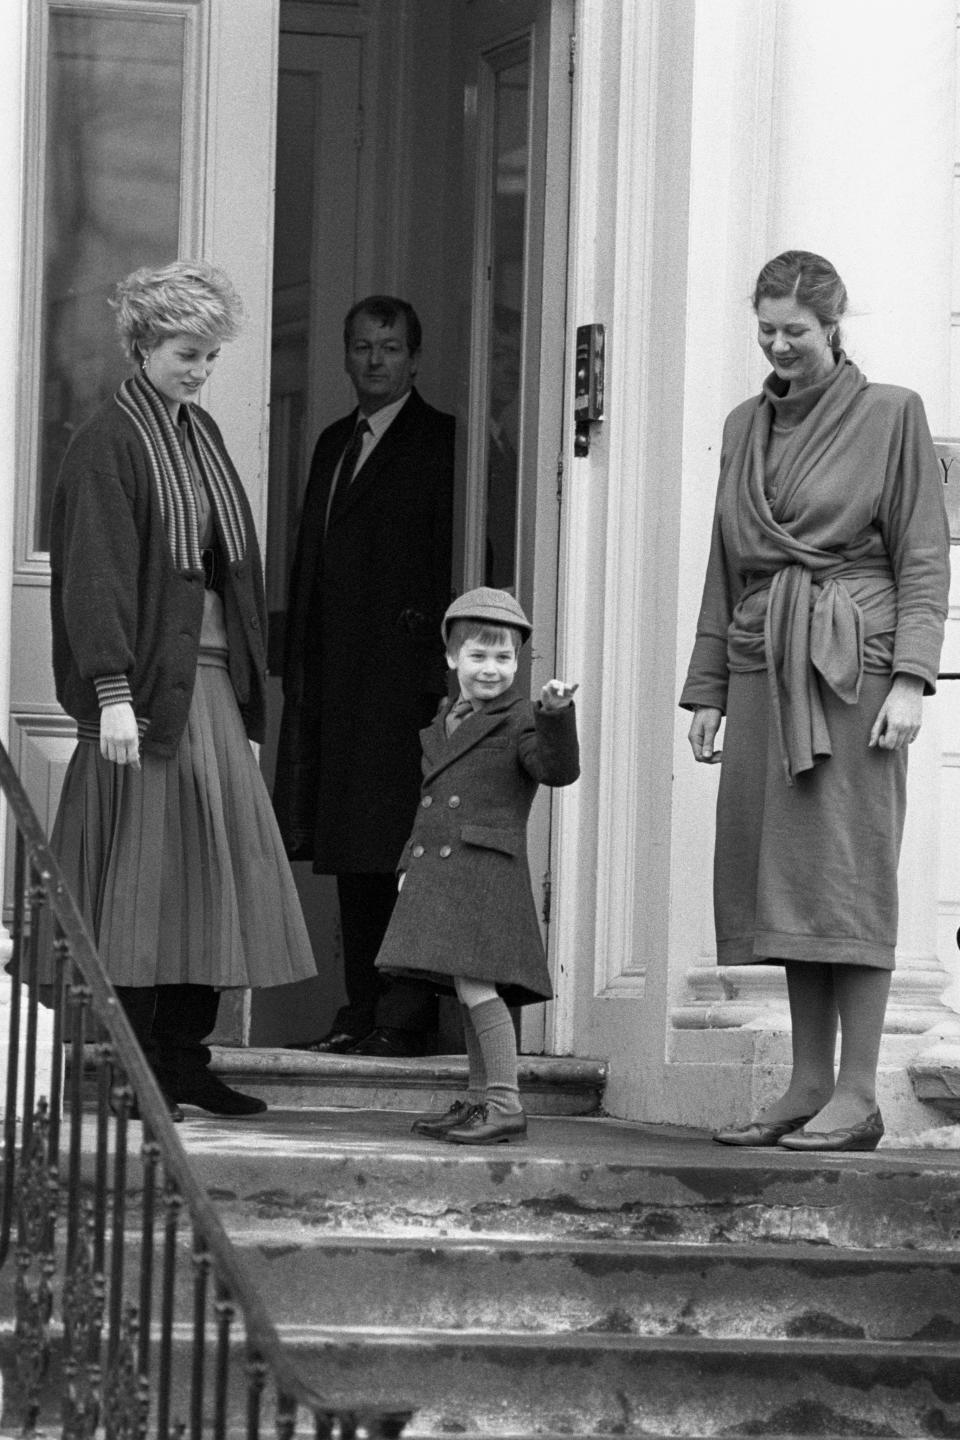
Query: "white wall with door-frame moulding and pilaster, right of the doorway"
557 0 956 1125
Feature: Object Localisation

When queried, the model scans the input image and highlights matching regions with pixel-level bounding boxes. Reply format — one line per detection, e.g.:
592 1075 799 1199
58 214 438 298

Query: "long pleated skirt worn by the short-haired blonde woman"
50 655 317 988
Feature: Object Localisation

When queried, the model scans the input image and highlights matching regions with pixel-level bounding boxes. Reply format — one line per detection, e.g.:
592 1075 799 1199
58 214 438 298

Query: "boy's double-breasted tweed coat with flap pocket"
377 687 580 1005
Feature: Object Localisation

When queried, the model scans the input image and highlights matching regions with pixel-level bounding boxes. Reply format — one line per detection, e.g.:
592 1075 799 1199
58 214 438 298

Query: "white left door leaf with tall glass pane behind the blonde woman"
7 0 278 1048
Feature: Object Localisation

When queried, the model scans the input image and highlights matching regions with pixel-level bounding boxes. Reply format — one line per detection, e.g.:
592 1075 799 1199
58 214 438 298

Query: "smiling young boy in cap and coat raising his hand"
377 586 580 1145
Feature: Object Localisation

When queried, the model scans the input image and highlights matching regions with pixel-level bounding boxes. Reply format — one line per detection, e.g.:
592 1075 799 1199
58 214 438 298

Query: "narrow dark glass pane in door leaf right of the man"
485 59 530 589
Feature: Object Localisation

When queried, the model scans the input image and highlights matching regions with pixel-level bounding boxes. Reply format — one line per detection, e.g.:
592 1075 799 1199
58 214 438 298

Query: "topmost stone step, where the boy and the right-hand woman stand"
180 1109 960 1257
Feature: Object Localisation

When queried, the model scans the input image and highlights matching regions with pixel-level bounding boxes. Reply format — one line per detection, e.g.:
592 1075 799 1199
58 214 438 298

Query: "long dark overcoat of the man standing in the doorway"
273 389 453 874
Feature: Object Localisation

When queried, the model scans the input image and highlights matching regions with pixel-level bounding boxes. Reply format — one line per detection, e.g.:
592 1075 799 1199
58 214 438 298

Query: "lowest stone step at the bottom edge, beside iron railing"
276 1326 960 1440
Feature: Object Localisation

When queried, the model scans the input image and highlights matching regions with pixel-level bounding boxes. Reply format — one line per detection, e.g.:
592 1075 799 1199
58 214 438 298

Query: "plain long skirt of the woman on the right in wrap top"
714 671 907 969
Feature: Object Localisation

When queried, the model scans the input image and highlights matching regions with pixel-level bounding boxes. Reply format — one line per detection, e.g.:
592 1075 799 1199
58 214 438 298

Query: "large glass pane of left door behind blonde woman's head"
35 10 186 550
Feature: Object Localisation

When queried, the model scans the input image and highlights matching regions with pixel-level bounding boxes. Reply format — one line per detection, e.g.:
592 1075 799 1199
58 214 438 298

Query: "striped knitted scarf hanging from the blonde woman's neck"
114 372 246 570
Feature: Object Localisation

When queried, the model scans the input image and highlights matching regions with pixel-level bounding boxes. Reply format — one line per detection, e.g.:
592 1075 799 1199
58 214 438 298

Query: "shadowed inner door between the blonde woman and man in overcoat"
250 14 363 1045
